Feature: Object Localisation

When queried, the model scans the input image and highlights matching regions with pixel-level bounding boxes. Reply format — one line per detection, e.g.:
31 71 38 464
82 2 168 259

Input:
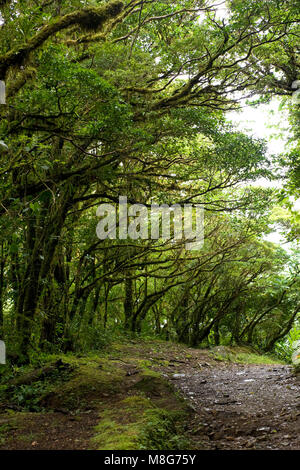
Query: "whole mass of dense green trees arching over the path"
0 0 300 363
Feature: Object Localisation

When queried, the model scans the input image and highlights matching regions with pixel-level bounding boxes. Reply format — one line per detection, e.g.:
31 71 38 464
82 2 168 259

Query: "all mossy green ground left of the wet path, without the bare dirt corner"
0 340 191 450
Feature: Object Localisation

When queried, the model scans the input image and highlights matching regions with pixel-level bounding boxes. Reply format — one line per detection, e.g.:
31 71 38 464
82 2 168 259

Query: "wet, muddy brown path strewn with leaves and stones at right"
171 363 300 450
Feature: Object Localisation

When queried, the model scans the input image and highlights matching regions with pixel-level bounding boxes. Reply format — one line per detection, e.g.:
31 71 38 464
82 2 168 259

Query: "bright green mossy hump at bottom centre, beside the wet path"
92 375 190 450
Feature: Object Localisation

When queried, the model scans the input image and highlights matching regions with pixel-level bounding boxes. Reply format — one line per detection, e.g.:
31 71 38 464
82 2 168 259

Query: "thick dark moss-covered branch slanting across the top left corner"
0 0 123 79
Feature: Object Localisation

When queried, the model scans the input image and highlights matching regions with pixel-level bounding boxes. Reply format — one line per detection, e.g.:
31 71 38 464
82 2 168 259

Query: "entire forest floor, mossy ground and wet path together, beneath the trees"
0 341 300 450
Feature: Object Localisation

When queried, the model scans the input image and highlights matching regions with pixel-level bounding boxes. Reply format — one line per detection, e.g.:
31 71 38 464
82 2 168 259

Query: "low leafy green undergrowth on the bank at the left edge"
0 354 125 412
